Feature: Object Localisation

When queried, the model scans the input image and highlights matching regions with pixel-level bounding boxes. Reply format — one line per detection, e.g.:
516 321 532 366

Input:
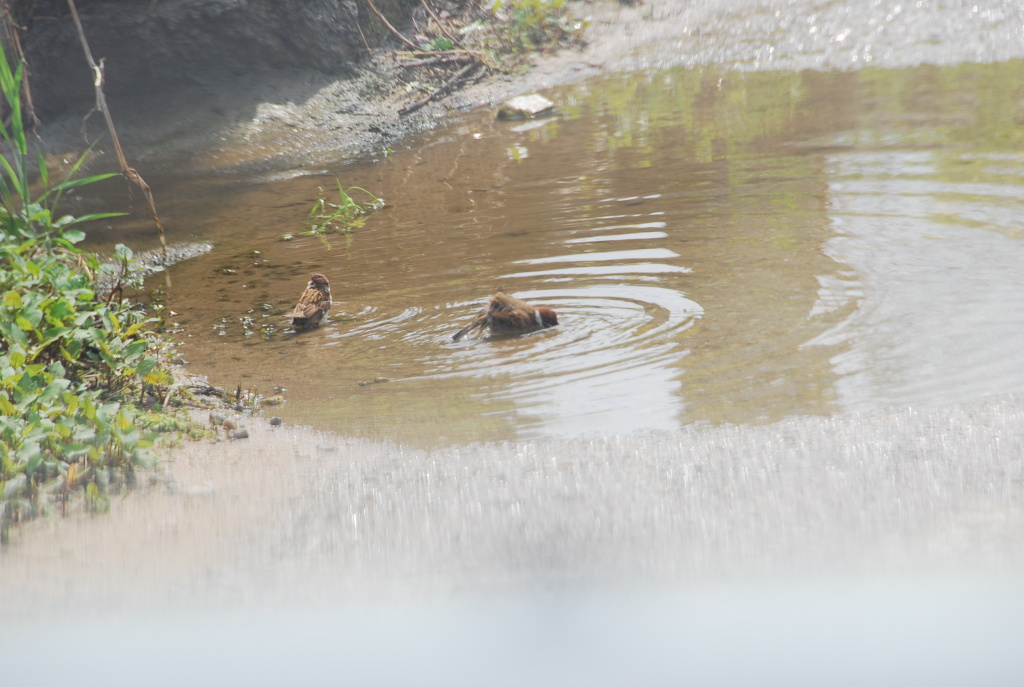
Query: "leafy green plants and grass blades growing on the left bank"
0 51 183 539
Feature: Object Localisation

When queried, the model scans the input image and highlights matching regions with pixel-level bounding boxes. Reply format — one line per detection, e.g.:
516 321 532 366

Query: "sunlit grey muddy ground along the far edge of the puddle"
29 0 1024 177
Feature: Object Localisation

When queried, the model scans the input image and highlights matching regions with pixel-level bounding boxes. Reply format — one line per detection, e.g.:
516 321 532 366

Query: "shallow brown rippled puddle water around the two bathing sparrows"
81 61 1024 444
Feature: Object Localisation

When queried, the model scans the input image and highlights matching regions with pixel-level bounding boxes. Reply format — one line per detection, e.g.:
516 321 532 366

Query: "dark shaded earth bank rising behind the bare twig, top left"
8 0 405 117
